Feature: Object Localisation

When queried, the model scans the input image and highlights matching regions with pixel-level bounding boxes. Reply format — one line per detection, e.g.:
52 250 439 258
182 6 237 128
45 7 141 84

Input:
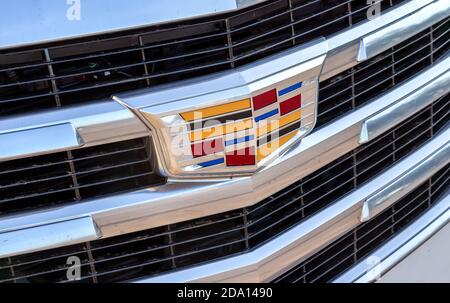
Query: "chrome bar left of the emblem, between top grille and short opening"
0 100 149 161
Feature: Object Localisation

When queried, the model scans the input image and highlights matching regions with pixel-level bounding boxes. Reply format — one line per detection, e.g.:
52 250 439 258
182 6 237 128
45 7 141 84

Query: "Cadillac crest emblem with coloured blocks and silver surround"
115 48 324 177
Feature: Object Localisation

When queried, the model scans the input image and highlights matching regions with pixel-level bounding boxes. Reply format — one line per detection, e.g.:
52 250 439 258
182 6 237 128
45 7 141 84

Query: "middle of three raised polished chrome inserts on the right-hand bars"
359 68 450 143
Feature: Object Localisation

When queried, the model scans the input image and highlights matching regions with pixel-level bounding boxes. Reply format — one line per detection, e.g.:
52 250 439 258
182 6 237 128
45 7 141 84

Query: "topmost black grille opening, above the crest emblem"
0 0 404 116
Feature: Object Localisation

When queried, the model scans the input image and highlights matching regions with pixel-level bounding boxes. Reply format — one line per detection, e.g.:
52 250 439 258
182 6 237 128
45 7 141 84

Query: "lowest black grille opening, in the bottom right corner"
274 165 450 283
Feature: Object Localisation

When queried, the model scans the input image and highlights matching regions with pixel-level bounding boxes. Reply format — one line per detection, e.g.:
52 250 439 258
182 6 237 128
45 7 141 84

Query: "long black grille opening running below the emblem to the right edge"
0 95 450 282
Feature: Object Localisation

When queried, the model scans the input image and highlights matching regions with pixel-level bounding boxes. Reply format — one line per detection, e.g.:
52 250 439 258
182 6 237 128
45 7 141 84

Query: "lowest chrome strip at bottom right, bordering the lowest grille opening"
333 190 450 283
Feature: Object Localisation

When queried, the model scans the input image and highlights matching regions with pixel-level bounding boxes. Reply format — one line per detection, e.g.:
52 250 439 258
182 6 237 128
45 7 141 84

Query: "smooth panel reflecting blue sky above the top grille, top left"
0 0 267 49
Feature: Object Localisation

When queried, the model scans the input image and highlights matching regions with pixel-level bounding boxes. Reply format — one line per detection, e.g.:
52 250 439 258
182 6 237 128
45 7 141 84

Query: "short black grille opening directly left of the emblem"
0 138 162 215
